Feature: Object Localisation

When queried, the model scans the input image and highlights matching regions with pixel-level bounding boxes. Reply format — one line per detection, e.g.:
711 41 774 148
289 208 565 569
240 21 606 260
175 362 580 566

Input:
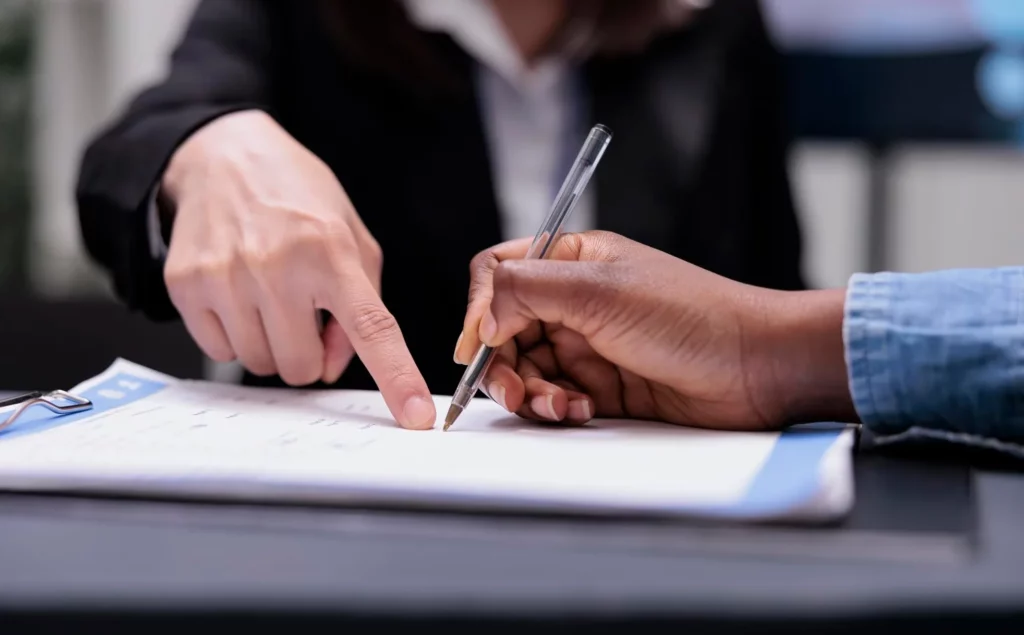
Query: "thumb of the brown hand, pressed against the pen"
479 260 629 346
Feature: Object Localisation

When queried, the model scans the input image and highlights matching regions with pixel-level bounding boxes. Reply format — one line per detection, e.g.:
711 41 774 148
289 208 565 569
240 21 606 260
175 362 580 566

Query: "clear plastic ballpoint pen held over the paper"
444 124 611 430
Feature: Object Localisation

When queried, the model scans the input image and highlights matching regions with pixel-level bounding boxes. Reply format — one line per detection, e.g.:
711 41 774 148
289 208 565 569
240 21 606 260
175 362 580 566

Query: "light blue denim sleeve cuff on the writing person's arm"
843 267 1024 456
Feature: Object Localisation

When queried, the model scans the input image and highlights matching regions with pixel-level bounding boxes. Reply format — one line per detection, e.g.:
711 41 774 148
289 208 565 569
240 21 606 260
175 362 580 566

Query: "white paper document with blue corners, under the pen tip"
0 359 853 521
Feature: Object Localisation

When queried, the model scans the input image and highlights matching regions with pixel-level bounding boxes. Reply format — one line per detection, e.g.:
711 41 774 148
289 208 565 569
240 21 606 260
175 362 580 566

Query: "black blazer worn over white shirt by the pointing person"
77 0 803 394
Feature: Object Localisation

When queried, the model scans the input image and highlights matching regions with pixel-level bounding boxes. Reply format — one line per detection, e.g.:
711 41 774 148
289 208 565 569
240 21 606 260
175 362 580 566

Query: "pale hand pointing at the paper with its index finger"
162 111 435 428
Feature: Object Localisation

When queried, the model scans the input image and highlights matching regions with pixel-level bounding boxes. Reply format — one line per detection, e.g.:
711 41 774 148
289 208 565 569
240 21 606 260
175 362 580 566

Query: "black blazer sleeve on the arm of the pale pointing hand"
76 0 274 320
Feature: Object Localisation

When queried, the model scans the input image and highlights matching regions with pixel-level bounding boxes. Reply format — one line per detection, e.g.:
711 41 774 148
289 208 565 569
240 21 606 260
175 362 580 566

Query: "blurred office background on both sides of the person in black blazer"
0 0 1024 389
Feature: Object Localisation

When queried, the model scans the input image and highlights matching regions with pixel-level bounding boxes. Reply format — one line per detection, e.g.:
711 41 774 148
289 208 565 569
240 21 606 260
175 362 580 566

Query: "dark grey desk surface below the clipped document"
0 389 1024 632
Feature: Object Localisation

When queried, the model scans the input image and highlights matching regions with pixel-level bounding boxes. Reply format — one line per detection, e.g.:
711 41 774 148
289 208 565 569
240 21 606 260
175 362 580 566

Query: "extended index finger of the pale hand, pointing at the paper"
326 263 437 429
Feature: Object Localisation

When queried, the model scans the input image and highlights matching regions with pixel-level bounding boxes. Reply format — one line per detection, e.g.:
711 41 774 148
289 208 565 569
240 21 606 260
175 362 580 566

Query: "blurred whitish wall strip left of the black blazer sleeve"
31 0 196 296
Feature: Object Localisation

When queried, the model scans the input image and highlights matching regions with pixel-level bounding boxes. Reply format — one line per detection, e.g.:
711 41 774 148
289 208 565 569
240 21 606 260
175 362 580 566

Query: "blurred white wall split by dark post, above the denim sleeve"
792 143 1024 287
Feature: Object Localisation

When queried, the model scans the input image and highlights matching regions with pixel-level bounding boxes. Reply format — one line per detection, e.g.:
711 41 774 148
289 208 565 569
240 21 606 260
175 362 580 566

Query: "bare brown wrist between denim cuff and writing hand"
751 289 857 426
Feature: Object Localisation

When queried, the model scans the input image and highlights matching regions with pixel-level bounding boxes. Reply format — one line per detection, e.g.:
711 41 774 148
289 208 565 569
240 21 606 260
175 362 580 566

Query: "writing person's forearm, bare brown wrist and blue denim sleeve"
755 267 1024 440
